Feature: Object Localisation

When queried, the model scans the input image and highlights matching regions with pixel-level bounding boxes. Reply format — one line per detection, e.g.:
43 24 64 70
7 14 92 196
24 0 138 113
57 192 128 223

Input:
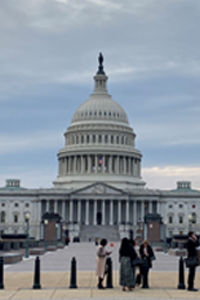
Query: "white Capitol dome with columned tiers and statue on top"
54 53 145 188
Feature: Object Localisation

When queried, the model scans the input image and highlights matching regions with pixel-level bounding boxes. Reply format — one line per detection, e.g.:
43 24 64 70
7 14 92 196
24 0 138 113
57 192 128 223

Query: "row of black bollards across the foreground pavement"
0 256 185 289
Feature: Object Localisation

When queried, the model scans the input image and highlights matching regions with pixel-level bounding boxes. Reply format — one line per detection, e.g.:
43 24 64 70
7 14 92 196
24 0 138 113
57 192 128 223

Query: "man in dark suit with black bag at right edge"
187 231 199 292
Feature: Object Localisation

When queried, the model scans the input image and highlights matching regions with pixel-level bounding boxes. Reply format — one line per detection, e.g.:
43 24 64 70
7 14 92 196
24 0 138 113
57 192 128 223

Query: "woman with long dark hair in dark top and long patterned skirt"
119 238 136 292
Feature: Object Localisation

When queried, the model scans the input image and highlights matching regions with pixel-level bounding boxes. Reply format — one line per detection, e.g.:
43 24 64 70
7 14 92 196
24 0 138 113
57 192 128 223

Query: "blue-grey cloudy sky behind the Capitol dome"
0 0 200 189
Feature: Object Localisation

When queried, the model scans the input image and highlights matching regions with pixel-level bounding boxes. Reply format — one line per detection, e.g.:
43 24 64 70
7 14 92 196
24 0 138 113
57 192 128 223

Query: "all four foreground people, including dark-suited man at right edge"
96 231 200 292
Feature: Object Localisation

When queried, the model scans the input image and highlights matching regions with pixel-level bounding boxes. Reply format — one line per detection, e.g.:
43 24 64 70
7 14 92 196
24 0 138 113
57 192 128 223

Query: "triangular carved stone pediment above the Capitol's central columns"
74 183 125 195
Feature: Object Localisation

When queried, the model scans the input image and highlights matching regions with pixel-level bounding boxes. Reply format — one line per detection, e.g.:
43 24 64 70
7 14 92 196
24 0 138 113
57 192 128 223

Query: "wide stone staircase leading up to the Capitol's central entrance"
80 225 120 242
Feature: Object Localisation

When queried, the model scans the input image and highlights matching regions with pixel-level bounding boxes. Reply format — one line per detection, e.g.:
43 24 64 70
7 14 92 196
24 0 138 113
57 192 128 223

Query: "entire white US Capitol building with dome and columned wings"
0 53 200 241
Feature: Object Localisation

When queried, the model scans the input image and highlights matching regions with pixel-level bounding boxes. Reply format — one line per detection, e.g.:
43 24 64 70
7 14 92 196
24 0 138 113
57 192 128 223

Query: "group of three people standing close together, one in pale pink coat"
96 237 155 291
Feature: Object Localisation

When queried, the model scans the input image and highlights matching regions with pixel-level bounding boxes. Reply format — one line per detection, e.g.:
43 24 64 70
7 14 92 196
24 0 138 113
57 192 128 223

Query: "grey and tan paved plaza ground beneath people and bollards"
0 243 200 300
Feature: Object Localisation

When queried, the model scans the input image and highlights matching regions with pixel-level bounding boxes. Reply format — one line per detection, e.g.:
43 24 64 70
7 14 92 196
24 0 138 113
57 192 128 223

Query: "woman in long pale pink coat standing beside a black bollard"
96 239 111 289
